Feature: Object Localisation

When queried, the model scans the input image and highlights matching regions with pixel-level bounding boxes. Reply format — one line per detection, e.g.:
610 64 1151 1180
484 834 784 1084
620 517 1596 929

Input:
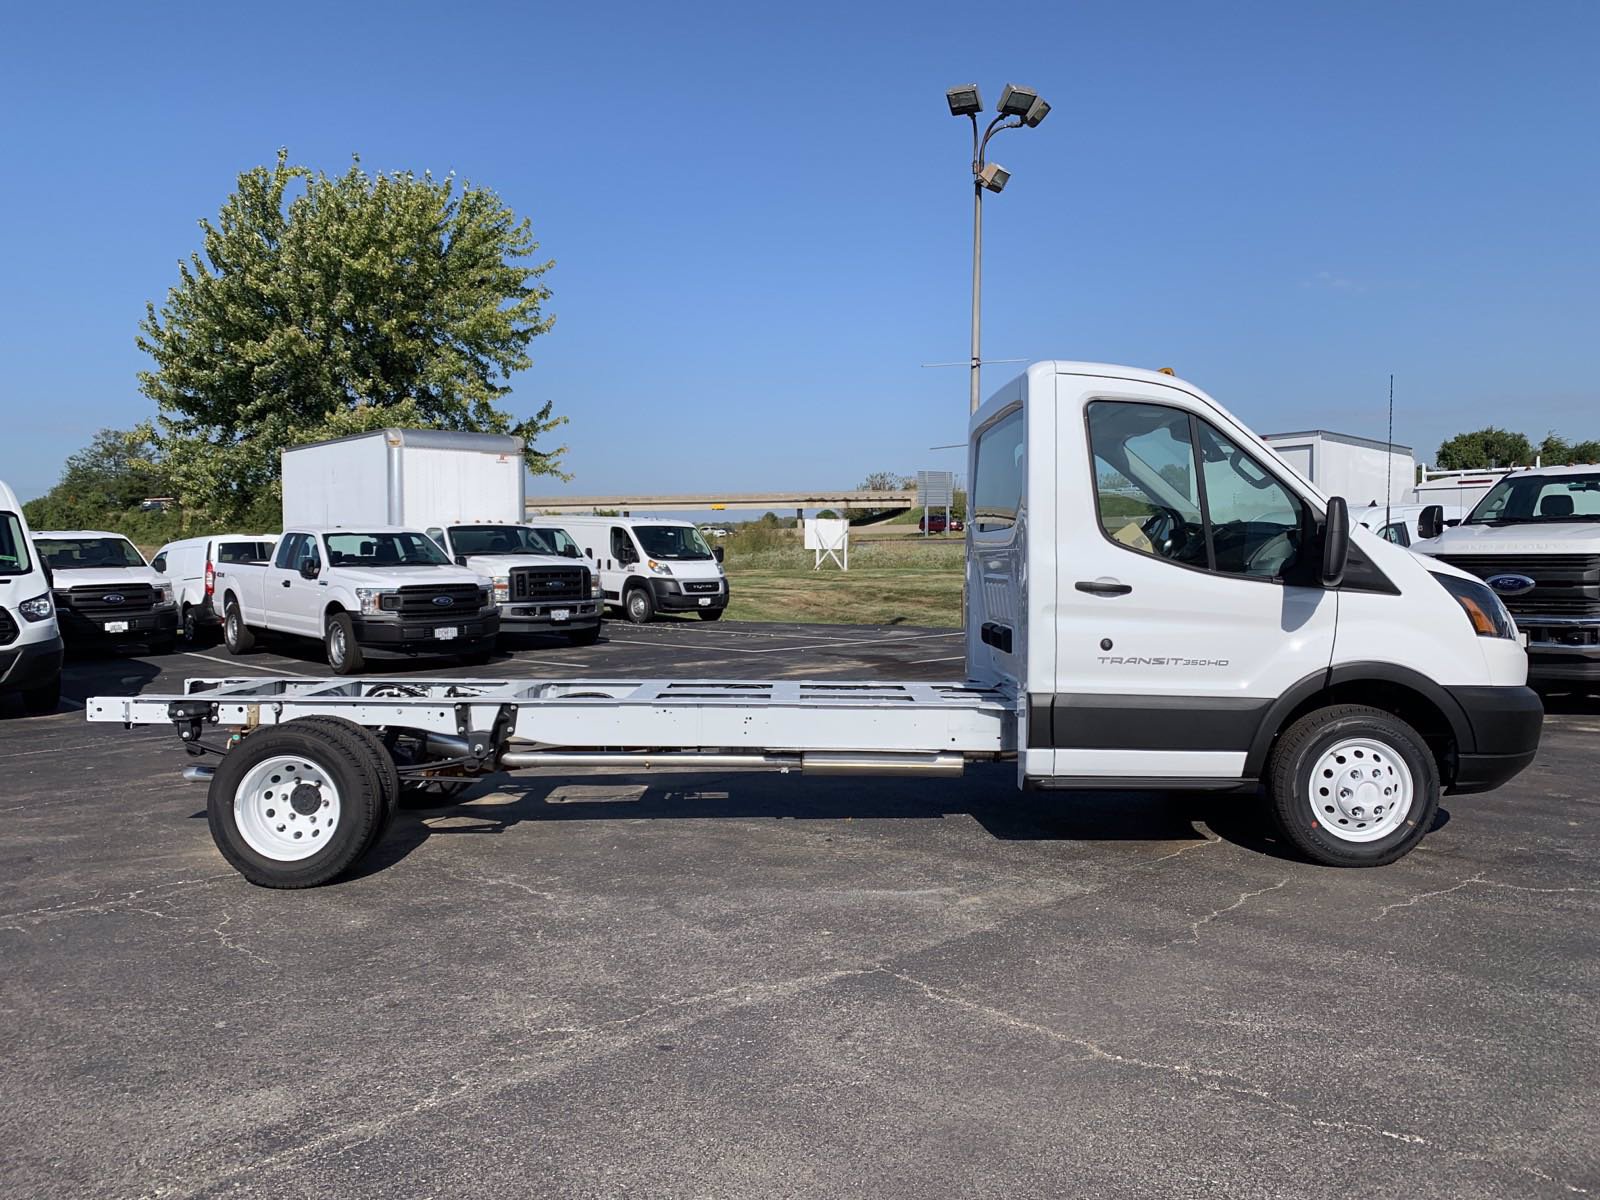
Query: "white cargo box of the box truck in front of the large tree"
283 429 526 530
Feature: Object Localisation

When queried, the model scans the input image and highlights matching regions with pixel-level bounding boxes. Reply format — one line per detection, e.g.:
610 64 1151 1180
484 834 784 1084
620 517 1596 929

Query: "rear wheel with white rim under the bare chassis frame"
206 720 384 888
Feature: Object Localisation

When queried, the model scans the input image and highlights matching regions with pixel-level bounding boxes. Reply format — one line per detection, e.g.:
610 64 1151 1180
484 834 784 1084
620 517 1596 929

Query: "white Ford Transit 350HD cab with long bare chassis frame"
86 362 1544 888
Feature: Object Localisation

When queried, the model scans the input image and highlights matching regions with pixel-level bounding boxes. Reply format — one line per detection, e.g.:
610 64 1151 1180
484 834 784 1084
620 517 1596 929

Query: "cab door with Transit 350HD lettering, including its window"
1051 387 1336 778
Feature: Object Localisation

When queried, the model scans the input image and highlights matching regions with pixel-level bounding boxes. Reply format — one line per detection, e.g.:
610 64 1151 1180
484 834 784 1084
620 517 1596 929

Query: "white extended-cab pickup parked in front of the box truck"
214 528 499 675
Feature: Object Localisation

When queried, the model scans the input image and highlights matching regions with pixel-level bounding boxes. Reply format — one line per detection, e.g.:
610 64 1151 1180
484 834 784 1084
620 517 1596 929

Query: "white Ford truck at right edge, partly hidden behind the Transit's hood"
1413 464 1600 690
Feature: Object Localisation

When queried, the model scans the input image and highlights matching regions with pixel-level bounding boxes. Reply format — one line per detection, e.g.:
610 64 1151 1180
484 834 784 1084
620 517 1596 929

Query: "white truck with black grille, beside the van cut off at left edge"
34 530 178 654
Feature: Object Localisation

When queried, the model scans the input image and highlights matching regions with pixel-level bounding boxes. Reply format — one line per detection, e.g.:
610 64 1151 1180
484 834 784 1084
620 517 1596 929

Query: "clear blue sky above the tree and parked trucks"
0 0 1600 496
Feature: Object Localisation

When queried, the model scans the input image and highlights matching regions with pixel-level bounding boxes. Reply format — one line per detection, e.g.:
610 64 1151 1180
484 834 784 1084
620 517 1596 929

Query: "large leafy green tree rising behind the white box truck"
138 150 566 518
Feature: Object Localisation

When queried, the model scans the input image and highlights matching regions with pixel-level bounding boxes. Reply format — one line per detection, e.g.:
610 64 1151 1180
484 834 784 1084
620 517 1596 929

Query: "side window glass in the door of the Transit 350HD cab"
1088 400 1309 579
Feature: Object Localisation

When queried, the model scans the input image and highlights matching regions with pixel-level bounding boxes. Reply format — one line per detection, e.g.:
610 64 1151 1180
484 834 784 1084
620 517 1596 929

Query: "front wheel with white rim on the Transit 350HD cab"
1267 704 1440 867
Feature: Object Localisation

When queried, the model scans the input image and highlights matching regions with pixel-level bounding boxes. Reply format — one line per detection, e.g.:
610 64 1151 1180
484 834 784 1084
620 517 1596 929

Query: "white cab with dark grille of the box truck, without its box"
427 522 600 643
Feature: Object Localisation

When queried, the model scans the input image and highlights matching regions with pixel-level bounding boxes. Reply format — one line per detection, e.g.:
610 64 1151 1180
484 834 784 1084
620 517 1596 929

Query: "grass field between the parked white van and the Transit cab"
726 530 963 627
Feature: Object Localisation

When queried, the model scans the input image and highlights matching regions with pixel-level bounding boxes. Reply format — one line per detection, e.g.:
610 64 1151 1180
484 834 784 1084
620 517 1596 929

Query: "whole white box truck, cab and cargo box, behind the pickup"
283 429 600 642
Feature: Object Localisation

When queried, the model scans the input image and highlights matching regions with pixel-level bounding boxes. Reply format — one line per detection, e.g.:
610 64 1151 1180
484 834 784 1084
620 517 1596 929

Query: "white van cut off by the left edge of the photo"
0 482 61 714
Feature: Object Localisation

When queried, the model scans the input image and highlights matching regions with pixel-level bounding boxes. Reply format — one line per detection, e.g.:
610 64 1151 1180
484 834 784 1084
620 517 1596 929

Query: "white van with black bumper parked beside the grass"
562 517 728 626
